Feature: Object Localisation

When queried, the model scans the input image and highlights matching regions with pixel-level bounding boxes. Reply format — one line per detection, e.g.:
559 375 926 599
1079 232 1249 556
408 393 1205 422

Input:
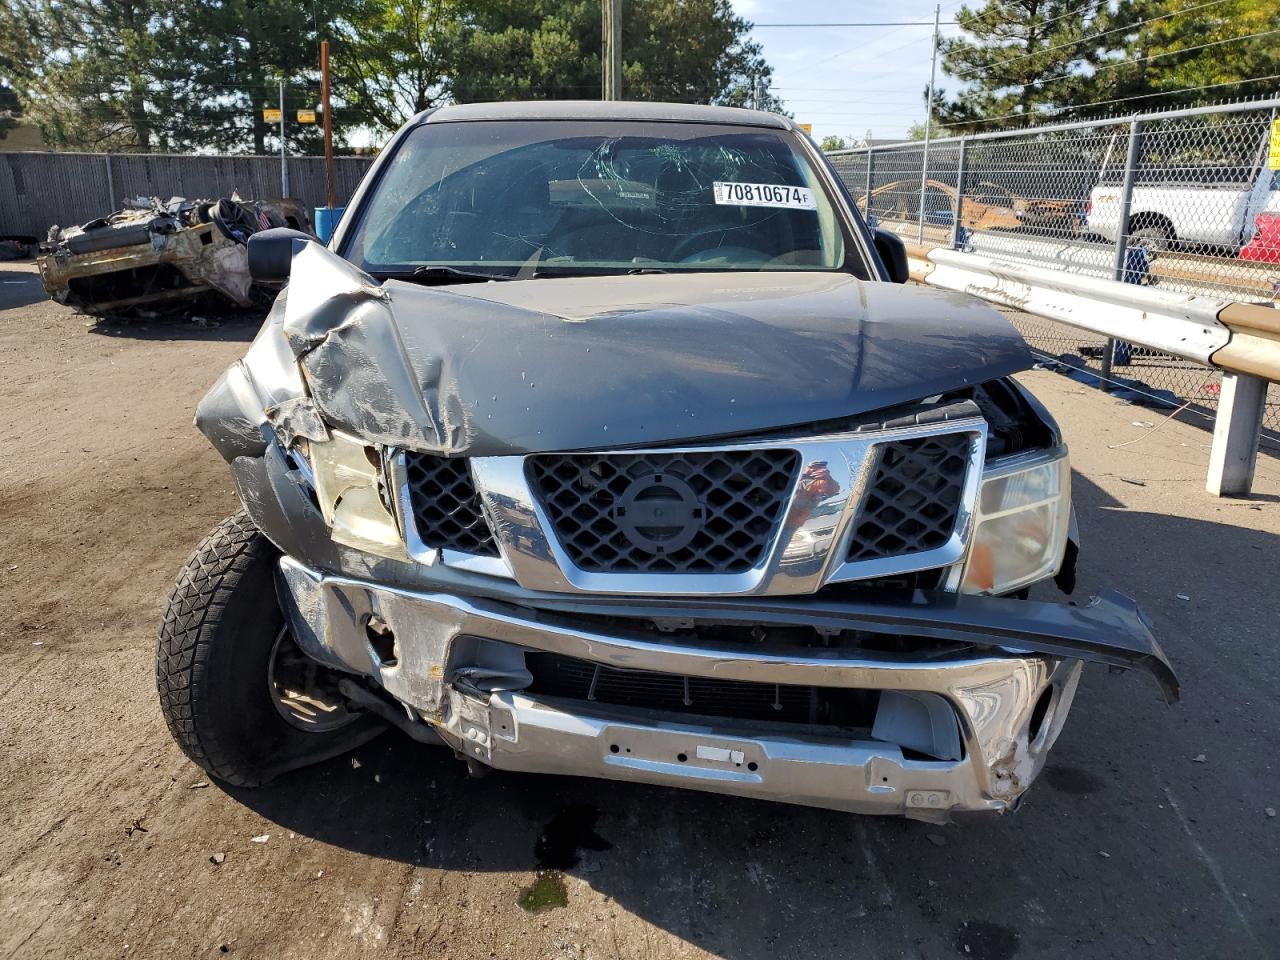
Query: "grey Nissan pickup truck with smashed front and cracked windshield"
156 102 1178 820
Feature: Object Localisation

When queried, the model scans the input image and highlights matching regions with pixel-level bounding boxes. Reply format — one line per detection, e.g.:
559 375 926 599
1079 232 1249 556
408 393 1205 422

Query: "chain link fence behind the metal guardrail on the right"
828 100 1280 442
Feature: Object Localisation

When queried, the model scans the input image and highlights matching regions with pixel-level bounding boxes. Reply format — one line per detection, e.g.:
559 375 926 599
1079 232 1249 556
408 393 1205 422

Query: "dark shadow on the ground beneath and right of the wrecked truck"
225 476 1280 960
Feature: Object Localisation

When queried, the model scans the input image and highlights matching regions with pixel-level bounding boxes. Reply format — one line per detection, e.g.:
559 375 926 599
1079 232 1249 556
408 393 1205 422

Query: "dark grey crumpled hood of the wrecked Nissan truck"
283 244 1032 456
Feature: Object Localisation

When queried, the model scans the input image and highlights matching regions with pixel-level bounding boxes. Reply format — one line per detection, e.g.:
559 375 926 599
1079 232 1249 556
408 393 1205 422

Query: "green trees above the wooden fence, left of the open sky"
0 0 781 154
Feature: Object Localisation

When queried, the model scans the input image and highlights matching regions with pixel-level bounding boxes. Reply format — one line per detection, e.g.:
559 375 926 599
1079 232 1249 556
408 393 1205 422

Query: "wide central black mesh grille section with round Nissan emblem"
526 449 800 573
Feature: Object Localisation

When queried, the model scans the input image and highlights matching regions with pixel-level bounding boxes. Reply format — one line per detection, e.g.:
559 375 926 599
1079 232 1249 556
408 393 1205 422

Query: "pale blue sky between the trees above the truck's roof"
733 0 980 140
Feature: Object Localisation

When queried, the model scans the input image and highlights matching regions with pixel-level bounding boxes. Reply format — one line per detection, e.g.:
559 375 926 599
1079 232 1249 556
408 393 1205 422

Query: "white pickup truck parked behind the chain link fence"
1085 163 1280 253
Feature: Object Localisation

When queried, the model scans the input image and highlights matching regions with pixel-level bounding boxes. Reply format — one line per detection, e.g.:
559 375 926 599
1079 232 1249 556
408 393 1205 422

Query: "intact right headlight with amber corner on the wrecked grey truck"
960 449 1071 594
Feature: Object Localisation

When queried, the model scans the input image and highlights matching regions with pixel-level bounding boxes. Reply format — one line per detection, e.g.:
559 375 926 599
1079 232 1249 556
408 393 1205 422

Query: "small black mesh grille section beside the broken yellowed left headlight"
404 451 498 557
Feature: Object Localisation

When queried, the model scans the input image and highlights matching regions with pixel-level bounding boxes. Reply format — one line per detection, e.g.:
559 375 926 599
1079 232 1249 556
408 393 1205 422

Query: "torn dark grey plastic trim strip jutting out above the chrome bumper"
522 590 1179 704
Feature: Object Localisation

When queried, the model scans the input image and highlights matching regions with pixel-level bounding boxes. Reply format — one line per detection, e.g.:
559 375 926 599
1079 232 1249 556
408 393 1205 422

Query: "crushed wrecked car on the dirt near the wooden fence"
38 197 311 316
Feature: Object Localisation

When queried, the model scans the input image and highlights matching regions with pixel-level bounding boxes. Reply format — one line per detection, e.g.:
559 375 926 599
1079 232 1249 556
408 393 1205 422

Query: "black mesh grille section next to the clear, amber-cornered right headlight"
849 433 972 562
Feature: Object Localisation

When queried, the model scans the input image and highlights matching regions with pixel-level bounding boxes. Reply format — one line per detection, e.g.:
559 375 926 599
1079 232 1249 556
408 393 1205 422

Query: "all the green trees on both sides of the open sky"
0 0 1280 154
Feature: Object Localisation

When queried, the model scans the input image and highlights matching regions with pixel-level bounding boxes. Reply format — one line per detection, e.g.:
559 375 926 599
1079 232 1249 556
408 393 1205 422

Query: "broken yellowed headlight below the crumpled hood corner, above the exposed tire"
298 429 408 559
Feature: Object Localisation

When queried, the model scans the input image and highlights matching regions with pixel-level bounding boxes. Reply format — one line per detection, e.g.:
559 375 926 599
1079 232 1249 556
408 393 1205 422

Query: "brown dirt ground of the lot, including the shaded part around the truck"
0 257 1280 960
